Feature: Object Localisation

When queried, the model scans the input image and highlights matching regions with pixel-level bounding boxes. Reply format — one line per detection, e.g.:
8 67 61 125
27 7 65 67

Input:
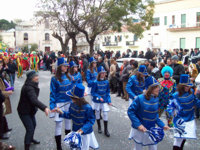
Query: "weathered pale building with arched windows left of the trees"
15 21 65 52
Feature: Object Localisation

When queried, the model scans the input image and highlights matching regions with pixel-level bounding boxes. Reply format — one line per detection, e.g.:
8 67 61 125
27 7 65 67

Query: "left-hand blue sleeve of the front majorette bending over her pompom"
127 97 141 129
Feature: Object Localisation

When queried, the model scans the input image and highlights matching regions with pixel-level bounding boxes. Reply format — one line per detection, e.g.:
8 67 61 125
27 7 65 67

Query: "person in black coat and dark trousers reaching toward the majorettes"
17 71 50 150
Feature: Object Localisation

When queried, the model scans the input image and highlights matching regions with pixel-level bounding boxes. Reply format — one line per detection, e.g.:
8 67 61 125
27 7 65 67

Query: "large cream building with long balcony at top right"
142 0 200 50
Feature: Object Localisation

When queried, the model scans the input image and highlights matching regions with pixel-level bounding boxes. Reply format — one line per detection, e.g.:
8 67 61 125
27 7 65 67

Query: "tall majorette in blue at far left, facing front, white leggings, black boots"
50 58 72 150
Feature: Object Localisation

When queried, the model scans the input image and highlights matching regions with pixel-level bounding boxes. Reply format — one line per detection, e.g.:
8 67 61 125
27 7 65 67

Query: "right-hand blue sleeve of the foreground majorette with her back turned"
81 106 95 133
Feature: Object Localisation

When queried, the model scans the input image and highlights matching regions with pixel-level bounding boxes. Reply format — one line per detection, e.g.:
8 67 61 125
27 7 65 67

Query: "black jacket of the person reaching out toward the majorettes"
17 80 47 115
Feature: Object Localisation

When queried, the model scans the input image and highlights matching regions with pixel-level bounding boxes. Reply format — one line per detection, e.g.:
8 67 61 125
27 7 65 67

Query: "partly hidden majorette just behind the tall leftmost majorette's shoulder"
69 61 82 85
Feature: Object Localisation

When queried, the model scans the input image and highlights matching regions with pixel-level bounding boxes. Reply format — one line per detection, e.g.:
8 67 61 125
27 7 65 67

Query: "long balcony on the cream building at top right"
167 22 200 32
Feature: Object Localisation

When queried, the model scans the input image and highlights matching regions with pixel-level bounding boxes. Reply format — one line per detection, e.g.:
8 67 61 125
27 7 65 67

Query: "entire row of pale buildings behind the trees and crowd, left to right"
0 0 200 53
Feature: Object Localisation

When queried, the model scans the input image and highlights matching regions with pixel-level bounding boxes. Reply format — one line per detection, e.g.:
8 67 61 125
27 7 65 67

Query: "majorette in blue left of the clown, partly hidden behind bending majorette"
126 65 148 106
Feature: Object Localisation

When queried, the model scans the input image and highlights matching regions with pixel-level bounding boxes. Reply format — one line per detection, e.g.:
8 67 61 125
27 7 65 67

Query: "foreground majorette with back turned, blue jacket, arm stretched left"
56 84 99 150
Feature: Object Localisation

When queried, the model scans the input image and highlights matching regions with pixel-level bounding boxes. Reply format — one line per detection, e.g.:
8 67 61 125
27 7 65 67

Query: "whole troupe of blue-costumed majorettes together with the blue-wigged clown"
50 57 200 150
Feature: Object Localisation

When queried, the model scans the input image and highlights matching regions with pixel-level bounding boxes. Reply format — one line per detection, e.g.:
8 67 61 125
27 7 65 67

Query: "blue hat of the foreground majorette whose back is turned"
66 83 85 98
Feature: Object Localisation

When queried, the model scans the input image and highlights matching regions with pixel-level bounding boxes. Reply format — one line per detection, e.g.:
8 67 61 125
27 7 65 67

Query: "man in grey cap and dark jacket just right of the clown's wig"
171 55 185 84
